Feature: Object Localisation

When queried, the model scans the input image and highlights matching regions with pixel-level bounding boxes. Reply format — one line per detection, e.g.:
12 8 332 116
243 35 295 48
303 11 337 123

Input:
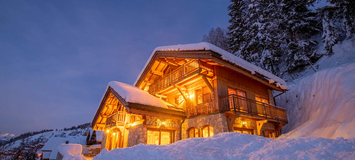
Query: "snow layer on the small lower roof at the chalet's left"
106 81 168 108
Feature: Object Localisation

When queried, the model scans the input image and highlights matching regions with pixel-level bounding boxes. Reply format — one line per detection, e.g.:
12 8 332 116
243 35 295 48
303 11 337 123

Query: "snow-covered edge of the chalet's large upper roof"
134 42 288 90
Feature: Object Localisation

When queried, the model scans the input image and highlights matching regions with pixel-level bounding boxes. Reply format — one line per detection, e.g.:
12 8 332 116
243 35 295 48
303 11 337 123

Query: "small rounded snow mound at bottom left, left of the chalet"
57 144 86 160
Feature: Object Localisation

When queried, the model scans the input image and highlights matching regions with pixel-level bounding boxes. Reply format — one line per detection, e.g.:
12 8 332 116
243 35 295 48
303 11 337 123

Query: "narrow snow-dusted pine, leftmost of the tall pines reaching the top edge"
228 0 248 56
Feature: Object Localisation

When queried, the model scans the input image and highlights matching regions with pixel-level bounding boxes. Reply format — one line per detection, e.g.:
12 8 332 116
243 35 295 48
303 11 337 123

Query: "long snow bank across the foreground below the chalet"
93 133 355 160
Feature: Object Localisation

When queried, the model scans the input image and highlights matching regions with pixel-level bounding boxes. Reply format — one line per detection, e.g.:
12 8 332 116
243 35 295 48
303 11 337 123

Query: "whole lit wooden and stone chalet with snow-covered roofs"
91 43 288 150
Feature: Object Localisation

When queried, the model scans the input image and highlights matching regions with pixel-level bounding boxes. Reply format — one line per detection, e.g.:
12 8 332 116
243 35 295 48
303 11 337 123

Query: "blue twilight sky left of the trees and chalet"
0 0 230 135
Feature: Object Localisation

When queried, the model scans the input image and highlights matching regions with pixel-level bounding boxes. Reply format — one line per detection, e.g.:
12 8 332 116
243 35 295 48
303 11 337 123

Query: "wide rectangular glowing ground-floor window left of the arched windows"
147 130 174 145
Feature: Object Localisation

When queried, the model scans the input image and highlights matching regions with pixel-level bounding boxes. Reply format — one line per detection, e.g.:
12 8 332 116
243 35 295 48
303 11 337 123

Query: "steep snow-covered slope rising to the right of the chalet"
276 39 355 138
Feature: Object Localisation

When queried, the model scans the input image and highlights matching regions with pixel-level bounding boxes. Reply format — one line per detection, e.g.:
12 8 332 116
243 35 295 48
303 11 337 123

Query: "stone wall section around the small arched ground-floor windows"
182 113 228 139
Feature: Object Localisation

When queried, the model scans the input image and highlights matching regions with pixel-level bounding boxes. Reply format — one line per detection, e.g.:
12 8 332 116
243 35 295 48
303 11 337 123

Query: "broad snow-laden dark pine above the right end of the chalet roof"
278 0 321 73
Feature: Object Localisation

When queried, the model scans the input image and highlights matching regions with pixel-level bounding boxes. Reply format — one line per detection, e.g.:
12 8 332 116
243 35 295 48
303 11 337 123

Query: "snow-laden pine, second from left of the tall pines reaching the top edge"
244 0 283 75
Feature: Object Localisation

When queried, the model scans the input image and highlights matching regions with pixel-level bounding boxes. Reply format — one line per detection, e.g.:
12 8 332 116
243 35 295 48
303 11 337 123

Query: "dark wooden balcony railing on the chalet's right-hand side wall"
220 94 288 123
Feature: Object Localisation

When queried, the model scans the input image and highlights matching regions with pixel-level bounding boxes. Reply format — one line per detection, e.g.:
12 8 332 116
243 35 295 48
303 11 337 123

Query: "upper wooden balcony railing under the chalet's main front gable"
148 60 200 93
